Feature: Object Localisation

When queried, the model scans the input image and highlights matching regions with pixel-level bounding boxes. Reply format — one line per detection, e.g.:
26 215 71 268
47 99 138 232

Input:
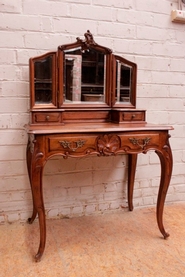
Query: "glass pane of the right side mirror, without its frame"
116 61 132 103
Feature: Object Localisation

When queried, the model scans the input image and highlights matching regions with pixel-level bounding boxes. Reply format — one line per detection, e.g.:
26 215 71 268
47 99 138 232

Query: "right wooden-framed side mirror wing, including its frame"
112 55 137 108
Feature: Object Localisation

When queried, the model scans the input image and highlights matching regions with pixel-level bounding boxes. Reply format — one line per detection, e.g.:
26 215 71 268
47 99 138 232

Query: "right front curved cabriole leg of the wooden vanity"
156 139 173 239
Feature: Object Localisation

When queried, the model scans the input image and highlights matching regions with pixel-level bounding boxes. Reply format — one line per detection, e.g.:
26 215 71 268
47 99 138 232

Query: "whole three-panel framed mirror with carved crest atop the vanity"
30 31 137 109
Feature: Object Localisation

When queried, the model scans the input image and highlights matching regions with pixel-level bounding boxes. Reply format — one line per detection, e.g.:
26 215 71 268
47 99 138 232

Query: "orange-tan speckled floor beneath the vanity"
0 204 185 277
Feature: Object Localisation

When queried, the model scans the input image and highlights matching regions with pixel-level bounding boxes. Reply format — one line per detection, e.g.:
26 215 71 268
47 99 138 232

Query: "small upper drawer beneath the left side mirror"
33 112 60 123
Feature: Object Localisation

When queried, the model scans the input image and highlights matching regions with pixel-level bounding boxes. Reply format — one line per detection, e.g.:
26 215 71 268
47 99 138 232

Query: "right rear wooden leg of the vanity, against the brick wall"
127 154 137 211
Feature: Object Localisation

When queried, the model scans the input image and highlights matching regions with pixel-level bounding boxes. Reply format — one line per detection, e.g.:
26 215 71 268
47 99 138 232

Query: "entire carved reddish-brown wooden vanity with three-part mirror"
27 31 173 261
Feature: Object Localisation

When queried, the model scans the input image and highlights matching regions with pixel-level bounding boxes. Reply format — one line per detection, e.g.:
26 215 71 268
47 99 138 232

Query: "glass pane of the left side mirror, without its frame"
34 56 52 104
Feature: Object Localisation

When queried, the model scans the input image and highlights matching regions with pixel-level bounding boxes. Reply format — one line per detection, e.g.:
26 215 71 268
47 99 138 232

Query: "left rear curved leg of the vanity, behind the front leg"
26 139 37 224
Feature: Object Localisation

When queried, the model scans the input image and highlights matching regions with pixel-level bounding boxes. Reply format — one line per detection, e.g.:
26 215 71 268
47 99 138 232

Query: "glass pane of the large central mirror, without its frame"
64 47 106 103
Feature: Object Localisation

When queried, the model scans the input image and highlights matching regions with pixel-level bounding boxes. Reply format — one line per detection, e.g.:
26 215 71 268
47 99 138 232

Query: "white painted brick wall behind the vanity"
0 0 185 222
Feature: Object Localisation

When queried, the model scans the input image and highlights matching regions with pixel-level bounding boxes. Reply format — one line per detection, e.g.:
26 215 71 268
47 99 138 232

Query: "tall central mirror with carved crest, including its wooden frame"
58 31 112 108
